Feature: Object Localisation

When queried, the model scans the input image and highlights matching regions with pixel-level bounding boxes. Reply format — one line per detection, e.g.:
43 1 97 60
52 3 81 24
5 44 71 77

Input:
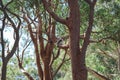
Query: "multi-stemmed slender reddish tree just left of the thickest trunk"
8 0 68 80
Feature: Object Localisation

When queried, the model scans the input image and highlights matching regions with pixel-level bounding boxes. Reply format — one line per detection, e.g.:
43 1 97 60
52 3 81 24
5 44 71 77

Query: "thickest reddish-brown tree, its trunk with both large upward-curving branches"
42 0 97 80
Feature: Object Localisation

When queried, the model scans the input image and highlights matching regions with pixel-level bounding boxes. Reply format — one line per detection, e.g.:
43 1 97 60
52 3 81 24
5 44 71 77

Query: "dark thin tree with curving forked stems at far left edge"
0 1 21 80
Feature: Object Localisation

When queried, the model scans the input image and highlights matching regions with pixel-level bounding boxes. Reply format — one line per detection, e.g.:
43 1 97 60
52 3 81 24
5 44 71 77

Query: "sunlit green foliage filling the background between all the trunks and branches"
0 0 120 80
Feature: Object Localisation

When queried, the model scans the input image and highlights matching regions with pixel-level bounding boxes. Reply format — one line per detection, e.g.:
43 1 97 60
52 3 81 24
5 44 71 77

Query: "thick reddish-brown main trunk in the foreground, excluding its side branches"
68 0 87 80
